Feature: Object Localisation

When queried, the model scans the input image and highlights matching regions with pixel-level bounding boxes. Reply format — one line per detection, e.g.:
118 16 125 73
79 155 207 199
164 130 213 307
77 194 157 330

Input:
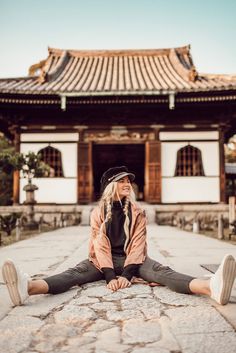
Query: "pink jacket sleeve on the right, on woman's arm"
124 212 147 267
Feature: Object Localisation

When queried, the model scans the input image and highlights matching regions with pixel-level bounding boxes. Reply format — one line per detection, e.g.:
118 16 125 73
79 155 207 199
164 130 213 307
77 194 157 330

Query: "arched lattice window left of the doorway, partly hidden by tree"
38 146 64 178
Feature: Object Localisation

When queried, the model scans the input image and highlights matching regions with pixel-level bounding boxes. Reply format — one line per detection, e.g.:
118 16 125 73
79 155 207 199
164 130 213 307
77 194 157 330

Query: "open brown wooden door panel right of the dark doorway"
145 141 161 203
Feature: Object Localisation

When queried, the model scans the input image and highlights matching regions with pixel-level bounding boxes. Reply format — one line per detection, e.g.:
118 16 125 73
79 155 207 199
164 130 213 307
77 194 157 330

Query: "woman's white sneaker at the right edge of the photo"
210 255 236 305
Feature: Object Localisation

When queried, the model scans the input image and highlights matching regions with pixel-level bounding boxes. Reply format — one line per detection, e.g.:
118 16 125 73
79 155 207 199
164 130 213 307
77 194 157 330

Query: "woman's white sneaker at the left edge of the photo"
2 260 30 306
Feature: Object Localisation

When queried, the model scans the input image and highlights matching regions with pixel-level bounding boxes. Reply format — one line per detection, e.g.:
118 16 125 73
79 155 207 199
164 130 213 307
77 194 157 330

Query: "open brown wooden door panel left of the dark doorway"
78 142 93 203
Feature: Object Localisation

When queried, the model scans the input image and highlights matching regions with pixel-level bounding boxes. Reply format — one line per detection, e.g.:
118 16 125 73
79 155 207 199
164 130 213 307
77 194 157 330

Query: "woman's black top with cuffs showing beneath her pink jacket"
102 198 139 283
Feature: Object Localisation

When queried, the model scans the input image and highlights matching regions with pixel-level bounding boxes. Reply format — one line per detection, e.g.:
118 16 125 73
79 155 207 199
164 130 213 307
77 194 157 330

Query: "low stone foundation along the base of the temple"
0 203 233 230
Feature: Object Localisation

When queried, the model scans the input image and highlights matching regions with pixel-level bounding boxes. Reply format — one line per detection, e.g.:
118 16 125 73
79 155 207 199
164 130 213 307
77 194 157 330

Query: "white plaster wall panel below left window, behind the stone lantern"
20 178 77 204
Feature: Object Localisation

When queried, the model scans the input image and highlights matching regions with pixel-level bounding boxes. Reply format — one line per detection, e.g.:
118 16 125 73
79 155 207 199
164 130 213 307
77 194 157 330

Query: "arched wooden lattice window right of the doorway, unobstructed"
175 145 204 176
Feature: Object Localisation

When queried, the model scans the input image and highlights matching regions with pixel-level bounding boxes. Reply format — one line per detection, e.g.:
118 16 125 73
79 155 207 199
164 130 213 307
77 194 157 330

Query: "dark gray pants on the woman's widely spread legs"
44 257 194 294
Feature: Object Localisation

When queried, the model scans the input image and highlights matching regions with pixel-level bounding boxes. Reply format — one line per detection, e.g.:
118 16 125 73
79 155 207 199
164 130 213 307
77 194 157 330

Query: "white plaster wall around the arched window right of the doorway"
161 141 220 203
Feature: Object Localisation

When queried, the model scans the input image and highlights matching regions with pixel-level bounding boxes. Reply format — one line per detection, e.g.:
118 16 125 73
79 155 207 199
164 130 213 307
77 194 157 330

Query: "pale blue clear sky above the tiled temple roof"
0 0 236 78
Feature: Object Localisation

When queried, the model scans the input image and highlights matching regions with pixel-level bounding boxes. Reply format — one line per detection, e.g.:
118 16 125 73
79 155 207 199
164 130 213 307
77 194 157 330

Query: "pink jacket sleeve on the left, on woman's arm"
90 209 114 269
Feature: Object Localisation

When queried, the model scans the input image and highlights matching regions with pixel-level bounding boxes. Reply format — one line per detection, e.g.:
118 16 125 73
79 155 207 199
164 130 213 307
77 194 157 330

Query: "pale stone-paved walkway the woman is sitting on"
0 224 236 353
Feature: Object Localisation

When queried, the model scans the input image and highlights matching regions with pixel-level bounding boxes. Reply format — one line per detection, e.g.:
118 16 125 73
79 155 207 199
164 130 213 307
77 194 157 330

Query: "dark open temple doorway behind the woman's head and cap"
93 144 145 200
